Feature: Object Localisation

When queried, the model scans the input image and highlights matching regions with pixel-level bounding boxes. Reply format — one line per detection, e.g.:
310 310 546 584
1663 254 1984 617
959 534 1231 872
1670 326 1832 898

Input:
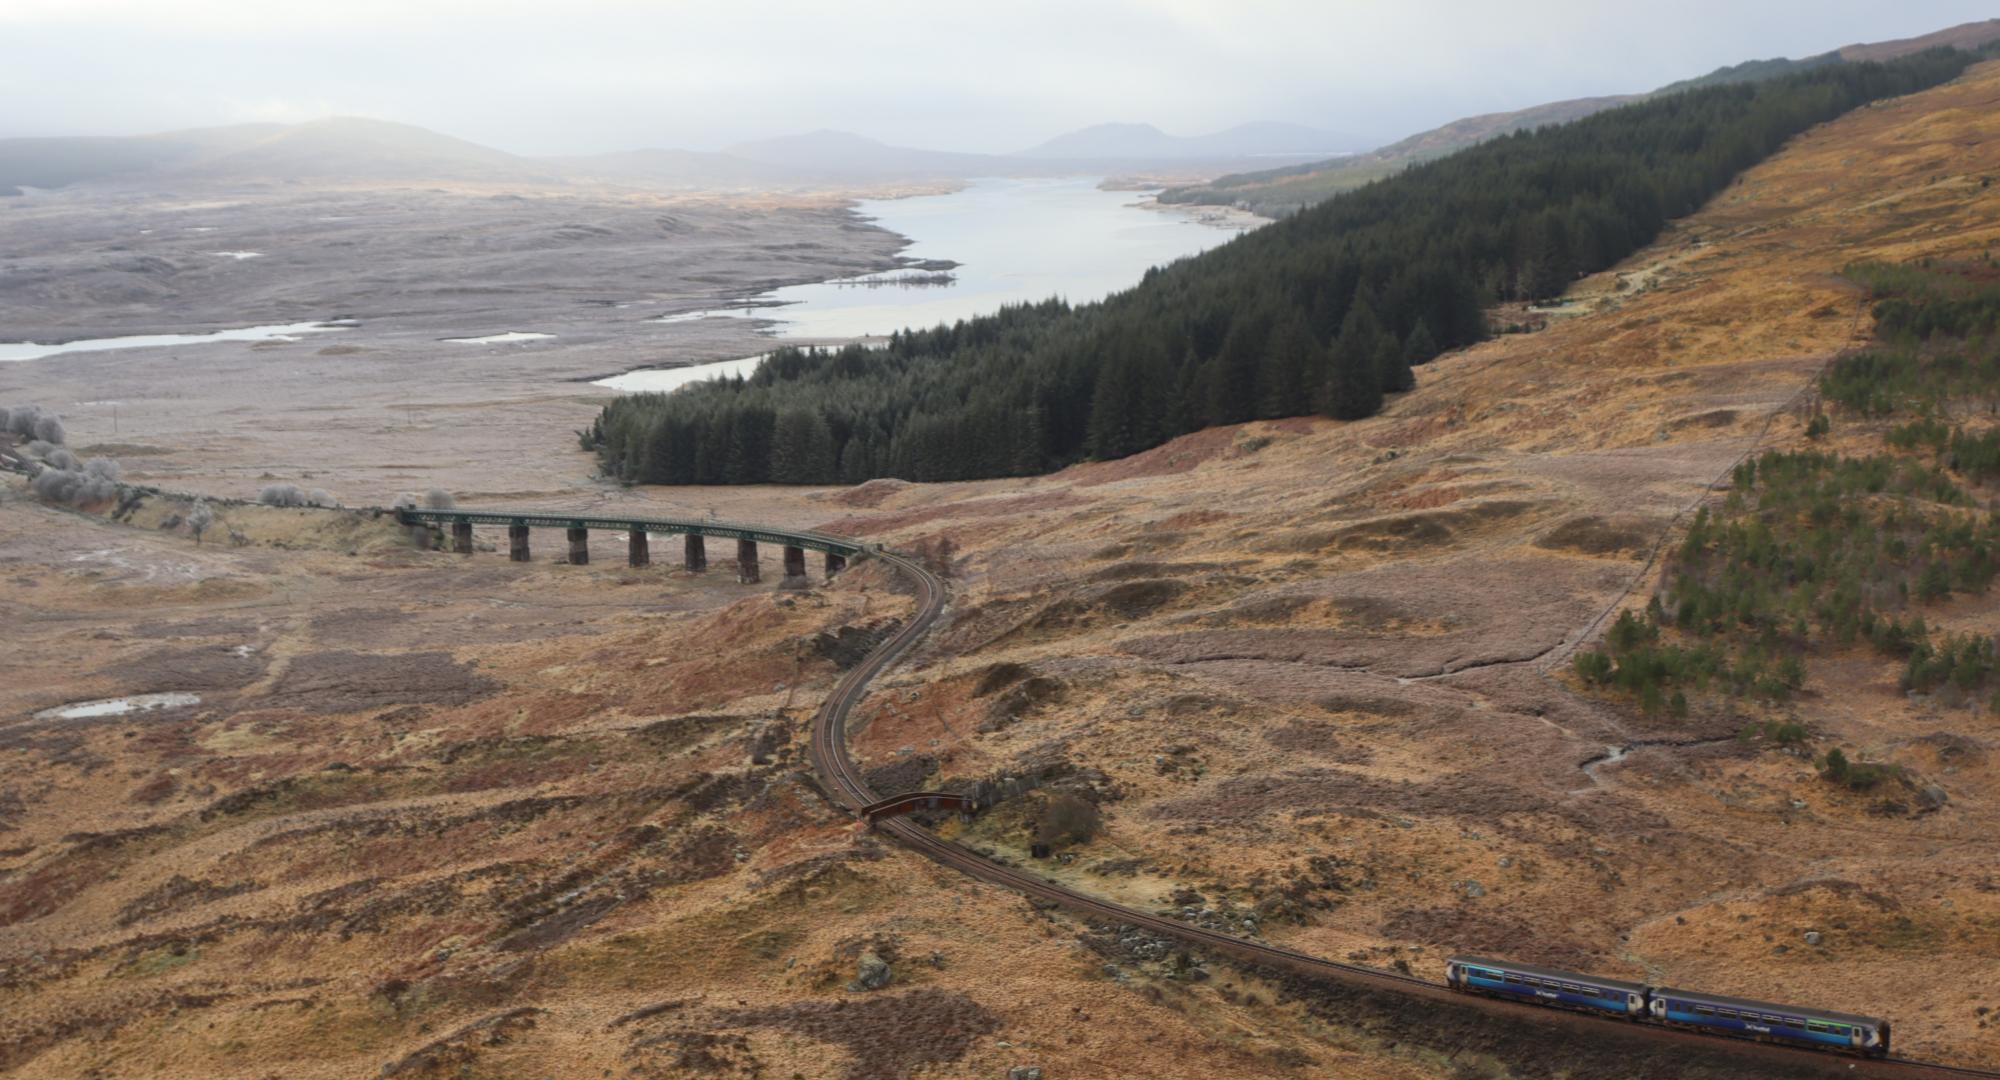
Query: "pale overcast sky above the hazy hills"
0 0 1994 154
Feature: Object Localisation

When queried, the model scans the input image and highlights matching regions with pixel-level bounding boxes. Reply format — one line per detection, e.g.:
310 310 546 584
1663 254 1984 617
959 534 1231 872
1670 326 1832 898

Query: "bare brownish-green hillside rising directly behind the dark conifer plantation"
1160 18 2000 216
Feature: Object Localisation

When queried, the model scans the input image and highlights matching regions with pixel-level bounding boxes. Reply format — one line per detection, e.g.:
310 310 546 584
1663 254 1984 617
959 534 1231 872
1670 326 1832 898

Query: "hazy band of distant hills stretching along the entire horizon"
0 18 2000 200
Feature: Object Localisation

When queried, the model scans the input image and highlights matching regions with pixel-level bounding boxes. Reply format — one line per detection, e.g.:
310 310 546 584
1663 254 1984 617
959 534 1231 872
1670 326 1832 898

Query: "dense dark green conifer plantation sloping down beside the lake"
582 50 1972 484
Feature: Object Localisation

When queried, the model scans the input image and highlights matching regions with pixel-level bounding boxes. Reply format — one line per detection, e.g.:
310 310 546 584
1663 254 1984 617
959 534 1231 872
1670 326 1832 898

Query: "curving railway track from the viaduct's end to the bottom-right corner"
810 552 2000 1078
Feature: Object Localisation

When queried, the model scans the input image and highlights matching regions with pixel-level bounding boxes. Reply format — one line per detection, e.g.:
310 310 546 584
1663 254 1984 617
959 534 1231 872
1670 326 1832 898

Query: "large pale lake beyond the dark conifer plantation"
598 178 1236 390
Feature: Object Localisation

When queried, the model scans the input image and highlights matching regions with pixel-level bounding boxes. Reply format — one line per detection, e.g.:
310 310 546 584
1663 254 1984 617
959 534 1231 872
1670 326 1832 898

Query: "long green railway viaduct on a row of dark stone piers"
396 508 870 582
